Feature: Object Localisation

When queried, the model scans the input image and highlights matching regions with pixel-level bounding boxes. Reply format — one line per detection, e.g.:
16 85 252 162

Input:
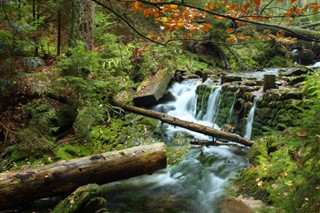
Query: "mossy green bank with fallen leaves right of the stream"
235 71 320 212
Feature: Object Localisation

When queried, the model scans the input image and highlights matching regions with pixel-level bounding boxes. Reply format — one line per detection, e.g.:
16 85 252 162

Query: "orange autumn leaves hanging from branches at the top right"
127 0 320 42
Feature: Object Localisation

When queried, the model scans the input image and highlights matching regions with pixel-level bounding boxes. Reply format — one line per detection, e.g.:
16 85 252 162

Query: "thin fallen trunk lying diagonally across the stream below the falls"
113 101 254 146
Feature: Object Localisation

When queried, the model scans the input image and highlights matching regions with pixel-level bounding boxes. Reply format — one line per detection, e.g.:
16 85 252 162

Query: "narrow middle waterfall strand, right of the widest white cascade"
203 86 221 122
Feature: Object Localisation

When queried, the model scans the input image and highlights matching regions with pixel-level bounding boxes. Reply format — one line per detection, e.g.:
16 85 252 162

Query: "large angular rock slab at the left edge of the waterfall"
133 69 172 107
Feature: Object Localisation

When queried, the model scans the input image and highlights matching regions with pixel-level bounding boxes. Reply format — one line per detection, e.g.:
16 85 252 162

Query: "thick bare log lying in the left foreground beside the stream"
0 143 166 210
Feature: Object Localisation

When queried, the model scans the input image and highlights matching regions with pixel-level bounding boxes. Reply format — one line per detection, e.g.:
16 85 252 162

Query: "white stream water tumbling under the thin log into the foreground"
104 80 248 213
